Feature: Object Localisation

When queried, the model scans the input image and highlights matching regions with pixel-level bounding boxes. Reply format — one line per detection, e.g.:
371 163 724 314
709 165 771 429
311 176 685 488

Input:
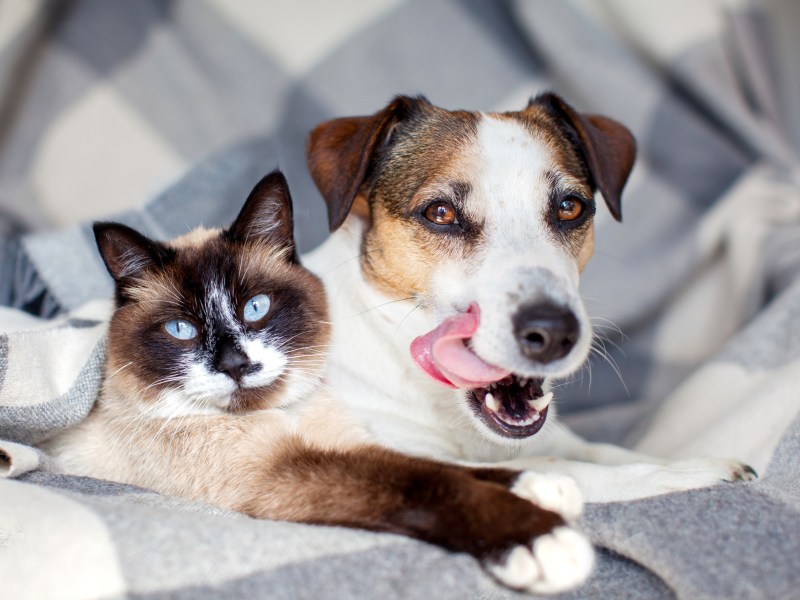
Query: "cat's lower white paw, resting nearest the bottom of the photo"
488 527 594 594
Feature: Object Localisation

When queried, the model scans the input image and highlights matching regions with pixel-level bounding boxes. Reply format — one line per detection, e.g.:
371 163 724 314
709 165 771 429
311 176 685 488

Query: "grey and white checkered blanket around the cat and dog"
0 0 800 600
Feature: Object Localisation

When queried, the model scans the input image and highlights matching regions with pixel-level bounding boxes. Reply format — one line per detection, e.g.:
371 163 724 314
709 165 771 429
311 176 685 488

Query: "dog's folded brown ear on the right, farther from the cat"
528 93 636 221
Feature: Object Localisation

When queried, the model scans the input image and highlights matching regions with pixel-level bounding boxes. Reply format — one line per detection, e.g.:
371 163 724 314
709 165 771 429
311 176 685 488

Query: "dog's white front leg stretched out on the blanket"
505 429 756 502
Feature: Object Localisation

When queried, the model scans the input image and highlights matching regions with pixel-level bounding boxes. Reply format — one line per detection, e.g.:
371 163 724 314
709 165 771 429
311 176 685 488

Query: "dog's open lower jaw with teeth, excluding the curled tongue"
467 375 553 438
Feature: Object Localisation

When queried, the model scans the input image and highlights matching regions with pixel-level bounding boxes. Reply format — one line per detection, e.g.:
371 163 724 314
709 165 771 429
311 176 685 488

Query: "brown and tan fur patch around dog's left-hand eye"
352 104 478 296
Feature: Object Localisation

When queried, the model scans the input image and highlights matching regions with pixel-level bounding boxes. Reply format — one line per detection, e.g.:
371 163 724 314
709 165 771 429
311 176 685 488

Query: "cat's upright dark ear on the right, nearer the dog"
226 170 297 262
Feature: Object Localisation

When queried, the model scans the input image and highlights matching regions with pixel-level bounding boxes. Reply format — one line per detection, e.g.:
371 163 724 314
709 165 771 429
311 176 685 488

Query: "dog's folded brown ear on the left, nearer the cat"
306 96 430 231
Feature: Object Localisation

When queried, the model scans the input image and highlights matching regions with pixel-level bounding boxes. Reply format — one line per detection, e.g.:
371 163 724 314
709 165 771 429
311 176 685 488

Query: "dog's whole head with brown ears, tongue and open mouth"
309 94 635 440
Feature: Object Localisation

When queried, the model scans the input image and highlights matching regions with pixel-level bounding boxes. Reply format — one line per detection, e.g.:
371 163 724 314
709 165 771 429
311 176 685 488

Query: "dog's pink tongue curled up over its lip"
411 304 509 388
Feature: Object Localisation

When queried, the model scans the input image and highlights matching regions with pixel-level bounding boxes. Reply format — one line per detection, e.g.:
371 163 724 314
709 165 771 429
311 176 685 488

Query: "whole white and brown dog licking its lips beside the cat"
307 94 755 501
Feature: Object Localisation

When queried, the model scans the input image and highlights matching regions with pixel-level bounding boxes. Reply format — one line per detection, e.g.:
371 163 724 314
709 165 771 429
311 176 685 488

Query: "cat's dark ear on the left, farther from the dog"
93 222 174 283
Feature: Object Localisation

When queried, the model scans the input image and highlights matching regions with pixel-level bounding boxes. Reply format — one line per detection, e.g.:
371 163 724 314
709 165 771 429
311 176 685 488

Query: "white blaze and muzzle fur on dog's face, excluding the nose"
446 115 591 377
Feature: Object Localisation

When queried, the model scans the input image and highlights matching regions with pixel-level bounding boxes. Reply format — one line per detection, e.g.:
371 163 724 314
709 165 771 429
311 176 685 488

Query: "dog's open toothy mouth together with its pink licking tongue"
411 304 553 438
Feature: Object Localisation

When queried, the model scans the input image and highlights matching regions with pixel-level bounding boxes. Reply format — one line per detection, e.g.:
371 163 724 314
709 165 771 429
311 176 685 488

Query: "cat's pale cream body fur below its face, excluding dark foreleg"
45 386 369 520
